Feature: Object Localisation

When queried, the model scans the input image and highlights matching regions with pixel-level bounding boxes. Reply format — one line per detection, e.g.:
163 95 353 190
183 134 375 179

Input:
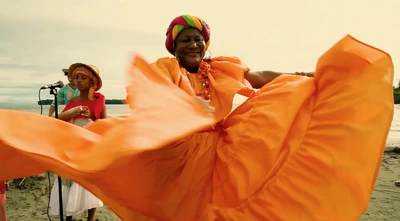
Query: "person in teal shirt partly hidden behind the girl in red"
49 69 79 117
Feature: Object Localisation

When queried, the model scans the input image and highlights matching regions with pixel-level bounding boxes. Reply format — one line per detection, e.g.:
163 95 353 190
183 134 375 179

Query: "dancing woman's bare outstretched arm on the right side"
244 71 314 89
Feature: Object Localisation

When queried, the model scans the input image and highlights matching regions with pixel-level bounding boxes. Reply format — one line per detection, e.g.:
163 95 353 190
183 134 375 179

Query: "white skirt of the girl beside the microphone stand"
49 179 103 216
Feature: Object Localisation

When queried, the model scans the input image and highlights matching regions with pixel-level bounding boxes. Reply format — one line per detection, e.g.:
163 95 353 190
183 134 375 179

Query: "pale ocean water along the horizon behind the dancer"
0 100 400 147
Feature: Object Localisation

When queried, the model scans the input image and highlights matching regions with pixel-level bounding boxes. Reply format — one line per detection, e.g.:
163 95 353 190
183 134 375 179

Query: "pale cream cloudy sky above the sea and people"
0 0 400 102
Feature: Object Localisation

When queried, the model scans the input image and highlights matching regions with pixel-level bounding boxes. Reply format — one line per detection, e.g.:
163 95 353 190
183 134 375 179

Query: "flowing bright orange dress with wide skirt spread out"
0 36 394 221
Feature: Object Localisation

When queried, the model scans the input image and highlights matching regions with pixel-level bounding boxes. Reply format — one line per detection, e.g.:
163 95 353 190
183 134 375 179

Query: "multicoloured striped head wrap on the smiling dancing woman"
165 15 210 55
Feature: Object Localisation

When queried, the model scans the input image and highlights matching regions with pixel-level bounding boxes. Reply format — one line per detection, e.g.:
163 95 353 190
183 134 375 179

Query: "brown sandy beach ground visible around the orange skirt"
2 152 400 221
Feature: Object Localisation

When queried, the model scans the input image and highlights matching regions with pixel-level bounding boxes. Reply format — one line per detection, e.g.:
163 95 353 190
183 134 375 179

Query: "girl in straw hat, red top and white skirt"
49 63 107 221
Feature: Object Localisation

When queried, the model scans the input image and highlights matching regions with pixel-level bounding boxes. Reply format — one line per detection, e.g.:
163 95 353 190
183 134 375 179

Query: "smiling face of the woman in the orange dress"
175 28 206 72
